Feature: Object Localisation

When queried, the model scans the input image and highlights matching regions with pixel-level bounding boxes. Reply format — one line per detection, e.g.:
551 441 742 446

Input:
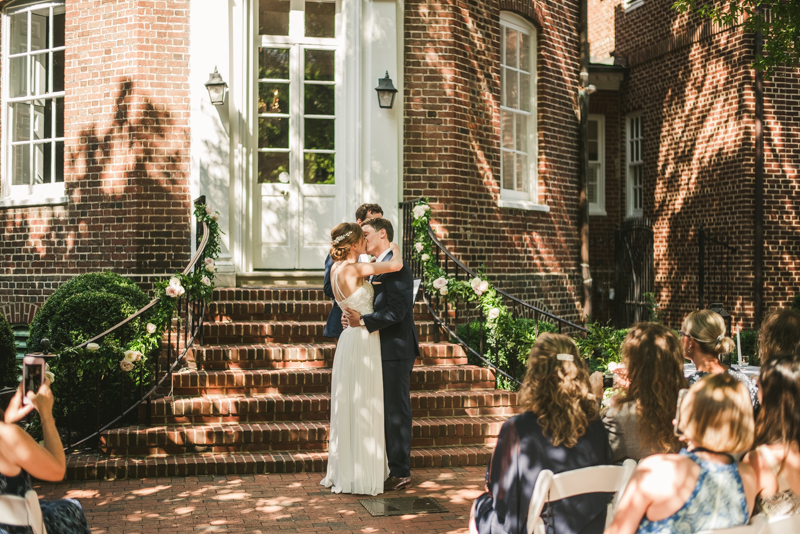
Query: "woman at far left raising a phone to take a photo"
0 382 89 534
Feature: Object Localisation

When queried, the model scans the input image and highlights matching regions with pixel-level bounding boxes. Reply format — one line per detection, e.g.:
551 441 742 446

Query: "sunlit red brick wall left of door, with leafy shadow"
0 0 190 316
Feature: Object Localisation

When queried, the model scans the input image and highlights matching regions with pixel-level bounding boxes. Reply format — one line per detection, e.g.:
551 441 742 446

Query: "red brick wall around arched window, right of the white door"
404 0 581 319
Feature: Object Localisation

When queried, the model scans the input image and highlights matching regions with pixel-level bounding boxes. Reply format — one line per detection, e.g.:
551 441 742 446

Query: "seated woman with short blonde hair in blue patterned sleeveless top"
606 373 756 534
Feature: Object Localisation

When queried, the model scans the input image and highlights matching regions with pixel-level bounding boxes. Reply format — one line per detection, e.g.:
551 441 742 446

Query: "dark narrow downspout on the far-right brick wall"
753 25 764 328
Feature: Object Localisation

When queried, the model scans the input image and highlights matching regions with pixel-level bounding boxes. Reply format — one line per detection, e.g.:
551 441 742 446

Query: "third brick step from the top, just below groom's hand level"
203 321 435 345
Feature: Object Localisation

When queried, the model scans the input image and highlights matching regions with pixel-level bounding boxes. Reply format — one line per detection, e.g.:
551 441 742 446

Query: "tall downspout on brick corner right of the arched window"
578 0 594 321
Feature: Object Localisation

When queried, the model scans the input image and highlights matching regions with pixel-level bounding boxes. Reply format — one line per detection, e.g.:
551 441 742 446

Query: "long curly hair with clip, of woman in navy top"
519 333 598 448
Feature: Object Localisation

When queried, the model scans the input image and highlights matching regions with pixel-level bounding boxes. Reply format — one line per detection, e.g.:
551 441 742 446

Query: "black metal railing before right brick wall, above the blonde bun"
697 225 736 310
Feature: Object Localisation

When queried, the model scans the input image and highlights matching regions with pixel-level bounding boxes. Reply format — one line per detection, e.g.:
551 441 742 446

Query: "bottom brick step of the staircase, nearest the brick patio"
66 446 493 484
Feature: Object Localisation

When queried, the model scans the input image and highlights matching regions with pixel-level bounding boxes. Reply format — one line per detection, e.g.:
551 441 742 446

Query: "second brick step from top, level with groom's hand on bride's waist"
206 300 431 323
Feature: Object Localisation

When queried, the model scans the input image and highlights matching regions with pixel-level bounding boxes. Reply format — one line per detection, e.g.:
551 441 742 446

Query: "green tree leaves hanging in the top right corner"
673 0 800 78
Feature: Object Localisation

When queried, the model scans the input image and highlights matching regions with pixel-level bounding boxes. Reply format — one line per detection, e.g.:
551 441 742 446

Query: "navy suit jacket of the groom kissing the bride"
363 252 419 360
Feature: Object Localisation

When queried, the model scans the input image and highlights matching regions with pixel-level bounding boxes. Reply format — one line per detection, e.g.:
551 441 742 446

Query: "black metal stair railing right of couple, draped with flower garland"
400 200 588 384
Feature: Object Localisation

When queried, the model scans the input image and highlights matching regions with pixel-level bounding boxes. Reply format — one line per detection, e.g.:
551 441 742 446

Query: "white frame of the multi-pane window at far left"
0 0 68 208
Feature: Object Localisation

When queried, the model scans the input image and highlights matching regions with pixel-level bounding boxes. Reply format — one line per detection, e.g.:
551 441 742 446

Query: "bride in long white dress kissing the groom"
321 223 403 495
